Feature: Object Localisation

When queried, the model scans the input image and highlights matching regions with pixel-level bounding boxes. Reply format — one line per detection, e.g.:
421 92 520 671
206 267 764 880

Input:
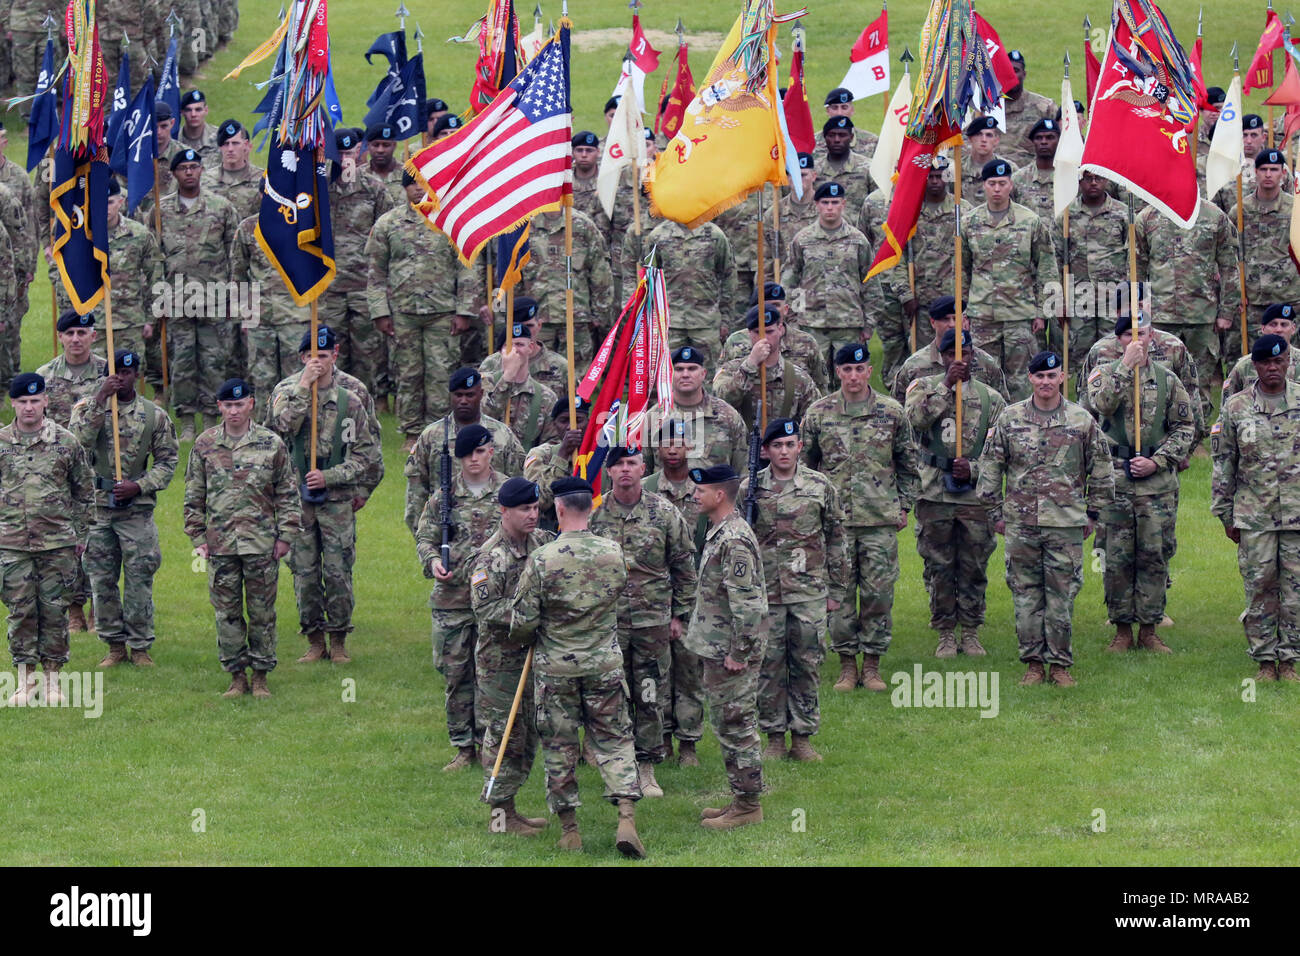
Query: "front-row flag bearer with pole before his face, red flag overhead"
905 329 1006 658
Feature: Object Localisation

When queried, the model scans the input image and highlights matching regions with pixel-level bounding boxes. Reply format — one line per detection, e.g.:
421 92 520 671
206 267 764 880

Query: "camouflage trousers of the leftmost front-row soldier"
0 548 81 665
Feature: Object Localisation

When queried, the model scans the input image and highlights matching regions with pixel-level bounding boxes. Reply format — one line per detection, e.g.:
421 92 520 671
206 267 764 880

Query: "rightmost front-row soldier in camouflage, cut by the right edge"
1210 336 1300 682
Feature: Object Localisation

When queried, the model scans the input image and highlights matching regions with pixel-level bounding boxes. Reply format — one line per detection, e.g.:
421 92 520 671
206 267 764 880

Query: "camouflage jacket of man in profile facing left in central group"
683 511 767 663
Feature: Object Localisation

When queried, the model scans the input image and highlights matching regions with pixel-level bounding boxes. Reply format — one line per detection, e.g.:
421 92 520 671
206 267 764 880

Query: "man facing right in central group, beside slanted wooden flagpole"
469 477 554 836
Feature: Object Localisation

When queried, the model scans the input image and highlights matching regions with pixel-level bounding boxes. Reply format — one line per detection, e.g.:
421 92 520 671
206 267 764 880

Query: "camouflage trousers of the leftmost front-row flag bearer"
82 509 163 650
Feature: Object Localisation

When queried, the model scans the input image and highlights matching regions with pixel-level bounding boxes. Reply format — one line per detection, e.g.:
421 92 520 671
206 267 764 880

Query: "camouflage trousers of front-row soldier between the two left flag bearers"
208 554 280 674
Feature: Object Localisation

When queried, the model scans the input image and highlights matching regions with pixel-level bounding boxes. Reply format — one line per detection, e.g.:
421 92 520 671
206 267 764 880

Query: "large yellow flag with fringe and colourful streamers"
649 0 805 228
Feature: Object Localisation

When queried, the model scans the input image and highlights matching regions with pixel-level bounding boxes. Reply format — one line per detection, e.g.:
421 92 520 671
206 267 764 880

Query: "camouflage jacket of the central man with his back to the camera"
508 531 628 678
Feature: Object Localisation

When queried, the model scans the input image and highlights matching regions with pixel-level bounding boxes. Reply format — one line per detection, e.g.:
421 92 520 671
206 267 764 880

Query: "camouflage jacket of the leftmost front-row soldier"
0 419 95 551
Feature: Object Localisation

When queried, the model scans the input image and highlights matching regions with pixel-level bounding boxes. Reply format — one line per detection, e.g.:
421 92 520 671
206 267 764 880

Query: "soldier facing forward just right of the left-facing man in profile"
740 419 849 761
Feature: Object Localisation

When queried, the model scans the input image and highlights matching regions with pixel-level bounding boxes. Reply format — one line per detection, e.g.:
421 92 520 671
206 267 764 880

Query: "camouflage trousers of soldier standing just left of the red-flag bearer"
831 525 898 656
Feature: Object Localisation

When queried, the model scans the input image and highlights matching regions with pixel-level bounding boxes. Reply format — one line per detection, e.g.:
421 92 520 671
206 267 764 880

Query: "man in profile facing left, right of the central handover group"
683 464 767 830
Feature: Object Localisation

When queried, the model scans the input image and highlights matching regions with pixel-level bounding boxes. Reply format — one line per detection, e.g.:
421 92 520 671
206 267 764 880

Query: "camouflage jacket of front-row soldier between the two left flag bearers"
183 424 303 555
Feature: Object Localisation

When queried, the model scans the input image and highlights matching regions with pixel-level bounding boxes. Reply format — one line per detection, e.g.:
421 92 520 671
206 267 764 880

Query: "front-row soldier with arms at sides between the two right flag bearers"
976 351 1114 687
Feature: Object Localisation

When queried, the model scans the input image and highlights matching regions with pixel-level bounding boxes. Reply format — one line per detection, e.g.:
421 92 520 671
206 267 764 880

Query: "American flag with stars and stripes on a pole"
407 26 573 264
